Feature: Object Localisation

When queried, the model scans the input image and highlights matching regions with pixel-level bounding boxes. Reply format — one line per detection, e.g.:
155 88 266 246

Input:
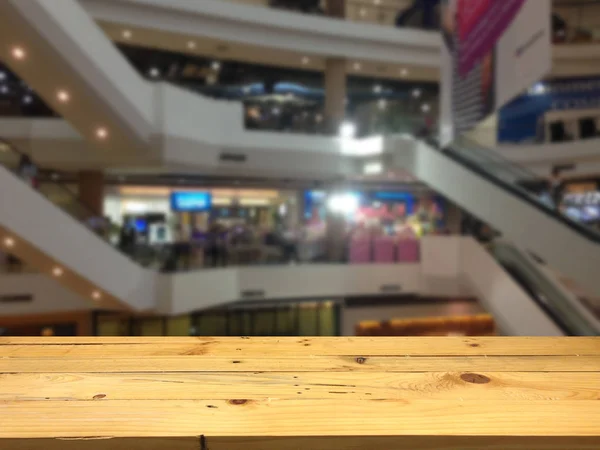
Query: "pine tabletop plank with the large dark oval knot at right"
0 372 600 402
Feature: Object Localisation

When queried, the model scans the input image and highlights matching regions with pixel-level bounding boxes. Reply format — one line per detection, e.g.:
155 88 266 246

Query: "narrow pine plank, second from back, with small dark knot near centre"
0 355 600 373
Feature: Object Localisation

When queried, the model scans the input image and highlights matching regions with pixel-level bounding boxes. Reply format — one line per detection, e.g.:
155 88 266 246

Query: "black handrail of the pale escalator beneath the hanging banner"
425 137 600 244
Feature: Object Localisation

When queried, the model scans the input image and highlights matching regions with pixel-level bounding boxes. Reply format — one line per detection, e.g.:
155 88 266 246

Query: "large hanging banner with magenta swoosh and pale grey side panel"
440 0 552 145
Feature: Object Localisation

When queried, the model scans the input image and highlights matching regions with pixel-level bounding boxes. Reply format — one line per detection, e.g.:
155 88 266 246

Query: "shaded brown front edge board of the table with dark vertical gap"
0 436 600 450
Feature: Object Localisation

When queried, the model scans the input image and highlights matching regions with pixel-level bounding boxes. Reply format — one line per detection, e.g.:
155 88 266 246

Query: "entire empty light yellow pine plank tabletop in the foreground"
0 338 600 450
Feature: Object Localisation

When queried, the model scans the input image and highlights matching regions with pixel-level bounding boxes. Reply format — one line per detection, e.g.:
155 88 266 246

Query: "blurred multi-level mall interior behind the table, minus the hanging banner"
0 0 600 336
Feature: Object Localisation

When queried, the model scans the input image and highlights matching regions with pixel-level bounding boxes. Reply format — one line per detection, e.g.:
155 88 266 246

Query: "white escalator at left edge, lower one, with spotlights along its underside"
0 142 157 310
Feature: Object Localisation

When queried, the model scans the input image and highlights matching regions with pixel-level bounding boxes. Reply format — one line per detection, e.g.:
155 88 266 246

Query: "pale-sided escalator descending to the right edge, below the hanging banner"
386 137 600 297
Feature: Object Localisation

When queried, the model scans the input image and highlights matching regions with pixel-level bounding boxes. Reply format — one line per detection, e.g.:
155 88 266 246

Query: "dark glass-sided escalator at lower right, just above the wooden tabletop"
490 240 600 336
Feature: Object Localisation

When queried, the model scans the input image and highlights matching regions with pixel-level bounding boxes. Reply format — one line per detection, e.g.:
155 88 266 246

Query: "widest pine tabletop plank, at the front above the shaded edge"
0 399 600 438
